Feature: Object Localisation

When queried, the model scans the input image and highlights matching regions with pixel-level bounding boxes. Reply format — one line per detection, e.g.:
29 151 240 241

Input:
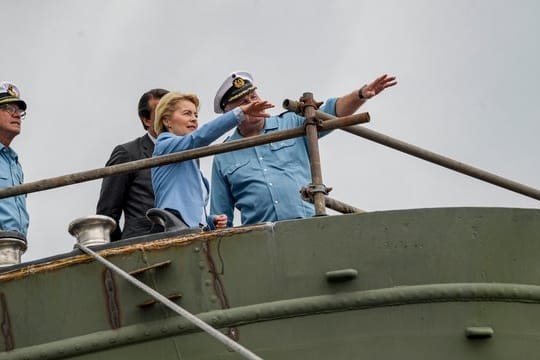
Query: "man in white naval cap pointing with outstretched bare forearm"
210 71 397 226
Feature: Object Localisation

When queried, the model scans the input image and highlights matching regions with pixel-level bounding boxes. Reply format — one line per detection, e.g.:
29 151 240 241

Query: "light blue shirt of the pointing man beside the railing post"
210 99 337 226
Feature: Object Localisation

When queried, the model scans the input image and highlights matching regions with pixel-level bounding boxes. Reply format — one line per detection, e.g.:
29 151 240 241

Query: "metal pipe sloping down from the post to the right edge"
283 99 540 200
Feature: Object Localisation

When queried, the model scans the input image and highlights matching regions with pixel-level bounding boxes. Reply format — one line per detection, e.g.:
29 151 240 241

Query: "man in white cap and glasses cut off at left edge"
0 82 29 237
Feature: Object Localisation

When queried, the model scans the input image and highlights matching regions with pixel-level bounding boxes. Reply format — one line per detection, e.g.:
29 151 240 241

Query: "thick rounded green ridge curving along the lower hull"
4 283 540 360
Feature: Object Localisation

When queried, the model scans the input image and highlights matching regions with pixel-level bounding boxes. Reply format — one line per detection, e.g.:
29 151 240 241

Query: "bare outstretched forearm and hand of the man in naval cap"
336 74 397 116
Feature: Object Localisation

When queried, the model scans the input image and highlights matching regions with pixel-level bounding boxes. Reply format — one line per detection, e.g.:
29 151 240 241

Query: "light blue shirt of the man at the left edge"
0 143 29 236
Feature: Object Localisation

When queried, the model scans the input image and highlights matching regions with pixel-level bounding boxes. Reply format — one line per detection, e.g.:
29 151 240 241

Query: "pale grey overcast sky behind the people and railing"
4 0 540 261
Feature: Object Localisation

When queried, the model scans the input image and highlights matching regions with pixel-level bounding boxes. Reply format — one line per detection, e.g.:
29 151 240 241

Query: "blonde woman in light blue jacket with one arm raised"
152 92 273 229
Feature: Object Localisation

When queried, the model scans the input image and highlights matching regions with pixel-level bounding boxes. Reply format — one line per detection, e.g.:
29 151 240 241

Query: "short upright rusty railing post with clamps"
300 92 328 216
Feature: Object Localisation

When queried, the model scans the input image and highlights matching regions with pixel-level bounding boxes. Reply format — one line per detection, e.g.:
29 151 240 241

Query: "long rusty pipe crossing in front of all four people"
0 113 369 199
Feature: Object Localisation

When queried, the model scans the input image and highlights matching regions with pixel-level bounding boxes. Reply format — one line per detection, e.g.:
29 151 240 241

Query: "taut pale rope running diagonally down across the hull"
75 243 263 360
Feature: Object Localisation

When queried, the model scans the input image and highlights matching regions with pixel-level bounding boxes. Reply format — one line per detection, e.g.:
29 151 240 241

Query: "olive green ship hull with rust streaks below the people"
0 208 540 359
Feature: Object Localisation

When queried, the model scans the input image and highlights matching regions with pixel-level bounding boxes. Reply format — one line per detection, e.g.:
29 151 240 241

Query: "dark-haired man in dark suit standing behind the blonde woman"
96 89 168 241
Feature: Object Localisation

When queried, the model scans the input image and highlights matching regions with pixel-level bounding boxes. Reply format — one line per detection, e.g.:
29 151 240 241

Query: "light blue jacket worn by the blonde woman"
152 108 243 227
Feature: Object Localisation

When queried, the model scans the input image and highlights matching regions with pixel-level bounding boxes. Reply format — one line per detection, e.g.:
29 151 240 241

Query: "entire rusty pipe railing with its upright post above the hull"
0 93 540 207
